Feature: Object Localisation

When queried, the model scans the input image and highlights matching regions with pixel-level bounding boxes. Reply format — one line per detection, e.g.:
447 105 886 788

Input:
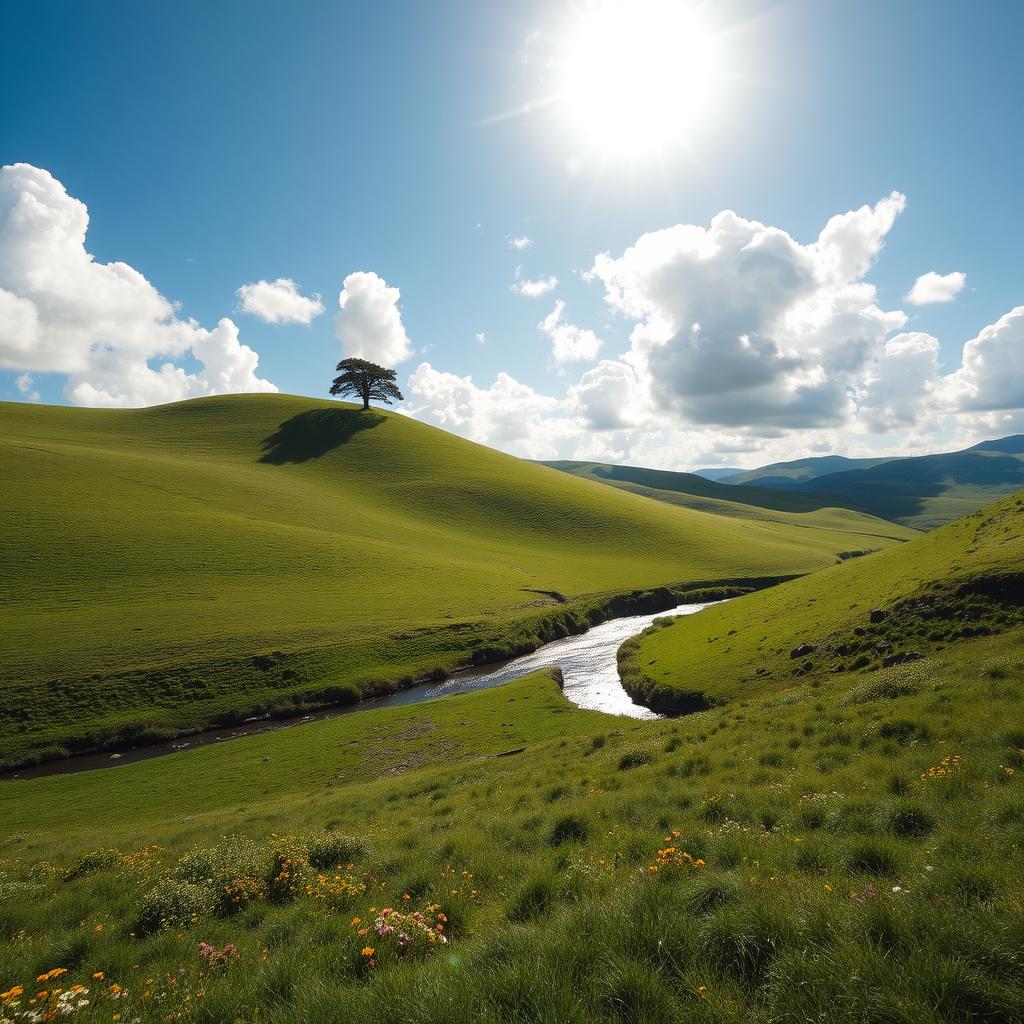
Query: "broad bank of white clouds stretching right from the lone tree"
410 193 1024 469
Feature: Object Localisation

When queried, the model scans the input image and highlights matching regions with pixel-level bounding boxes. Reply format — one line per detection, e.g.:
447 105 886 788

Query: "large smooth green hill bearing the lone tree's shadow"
0 395 913 763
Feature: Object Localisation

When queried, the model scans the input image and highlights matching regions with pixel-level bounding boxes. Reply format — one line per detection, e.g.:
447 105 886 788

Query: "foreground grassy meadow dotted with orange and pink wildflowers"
0 626 1024 1024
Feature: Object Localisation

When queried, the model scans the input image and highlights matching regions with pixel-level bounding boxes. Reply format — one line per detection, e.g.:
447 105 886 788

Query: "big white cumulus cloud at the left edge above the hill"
0 164 276 407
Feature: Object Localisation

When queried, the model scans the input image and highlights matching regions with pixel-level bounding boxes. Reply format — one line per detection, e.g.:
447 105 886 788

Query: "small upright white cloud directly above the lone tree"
334 270 413 367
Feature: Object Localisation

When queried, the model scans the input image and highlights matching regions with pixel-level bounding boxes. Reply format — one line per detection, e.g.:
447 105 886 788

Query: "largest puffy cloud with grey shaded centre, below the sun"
588 193 906 432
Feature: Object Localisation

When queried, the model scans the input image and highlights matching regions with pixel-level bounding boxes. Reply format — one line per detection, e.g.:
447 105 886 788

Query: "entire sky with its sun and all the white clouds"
0 0 1024 469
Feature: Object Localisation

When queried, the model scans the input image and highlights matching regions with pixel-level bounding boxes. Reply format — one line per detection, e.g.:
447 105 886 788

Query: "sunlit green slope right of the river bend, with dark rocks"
620 496 1024 710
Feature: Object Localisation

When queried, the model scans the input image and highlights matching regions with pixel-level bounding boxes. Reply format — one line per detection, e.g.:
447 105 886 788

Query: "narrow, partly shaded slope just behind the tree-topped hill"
543 462 913 540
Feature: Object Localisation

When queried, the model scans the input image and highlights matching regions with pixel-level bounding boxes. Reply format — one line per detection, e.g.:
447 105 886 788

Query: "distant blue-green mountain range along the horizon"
546 434 1024 529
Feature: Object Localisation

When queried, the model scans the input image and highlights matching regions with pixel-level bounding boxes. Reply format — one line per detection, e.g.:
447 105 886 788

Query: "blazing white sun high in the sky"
556 0 723 159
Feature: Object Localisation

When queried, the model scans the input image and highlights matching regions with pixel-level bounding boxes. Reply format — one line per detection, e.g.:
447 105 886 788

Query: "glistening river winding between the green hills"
0 602 715 779
